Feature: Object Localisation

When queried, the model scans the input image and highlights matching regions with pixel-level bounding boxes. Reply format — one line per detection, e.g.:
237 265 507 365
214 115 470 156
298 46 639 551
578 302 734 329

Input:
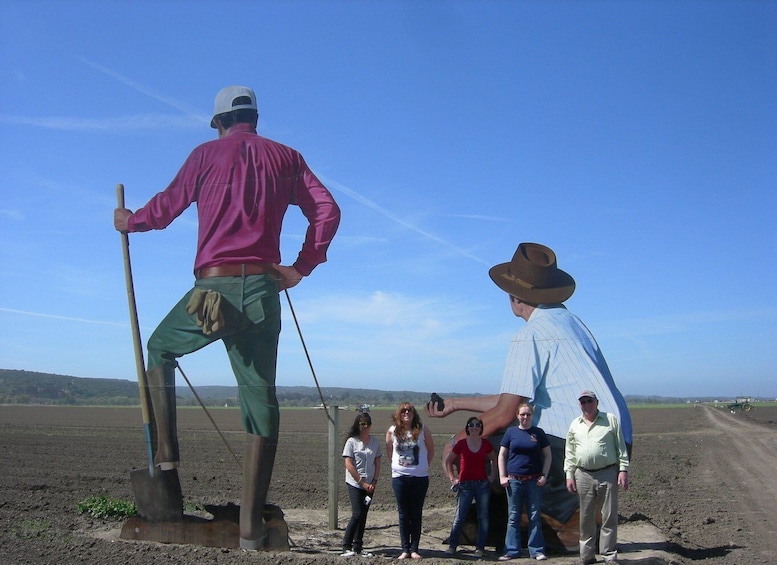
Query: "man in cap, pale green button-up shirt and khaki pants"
564 390 629 565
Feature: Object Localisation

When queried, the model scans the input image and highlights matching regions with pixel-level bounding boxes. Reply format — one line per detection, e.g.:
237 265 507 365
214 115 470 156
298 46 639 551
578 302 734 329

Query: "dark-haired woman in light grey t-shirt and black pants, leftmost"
341 412 381 557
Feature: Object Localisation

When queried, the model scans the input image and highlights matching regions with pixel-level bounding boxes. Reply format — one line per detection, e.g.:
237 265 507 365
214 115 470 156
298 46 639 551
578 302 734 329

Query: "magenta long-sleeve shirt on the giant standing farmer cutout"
127 124 340 276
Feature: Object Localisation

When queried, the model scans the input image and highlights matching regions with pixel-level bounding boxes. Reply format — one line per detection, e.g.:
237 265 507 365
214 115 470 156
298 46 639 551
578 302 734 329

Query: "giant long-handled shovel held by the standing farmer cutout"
116 184 183 522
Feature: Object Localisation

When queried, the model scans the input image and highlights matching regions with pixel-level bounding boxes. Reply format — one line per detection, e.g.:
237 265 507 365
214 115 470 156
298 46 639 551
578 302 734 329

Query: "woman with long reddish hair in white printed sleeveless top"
386 402 434 559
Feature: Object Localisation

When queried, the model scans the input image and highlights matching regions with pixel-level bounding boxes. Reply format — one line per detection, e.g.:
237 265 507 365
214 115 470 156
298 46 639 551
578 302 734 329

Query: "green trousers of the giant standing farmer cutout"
148 275 281 439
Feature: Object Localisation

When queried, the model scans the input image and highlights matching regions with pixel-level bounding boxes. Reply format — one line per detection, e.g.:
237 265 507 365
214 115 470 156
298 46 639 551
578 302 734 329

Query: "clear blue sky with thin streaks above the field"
0 0 777 396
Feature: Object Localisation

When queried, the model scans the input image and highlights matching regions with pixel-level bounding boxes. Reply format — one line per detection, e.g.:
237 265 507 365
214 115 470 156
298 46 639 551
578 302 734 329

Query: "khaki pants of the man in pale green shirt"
575 465 618 562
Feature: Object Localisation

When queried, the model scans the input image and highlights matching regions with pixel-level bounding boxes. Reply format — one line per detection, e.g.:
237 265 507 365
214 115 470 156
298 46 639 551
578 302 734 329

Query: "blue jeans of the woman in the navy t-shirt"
505 479 545 557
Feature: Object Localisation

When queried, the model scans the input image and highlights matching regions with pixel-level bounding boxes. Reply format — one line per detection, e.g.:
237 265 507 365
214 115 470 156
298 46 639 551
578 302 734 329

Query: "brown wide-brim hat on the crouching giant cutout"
488 243 575 304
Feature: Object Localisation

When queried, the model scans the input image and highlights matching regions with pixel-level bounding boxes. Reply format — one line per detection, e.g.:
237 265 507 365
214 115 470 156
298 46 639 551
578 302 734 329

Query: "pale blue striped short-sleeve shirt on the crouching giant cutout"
501 304 631 444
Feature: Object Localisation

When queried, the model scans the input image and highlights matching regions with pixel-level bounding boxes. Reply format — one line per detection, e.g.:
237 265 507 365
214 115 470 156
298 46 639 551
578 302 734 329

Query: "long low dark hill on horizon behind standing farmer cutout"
0 369 473 407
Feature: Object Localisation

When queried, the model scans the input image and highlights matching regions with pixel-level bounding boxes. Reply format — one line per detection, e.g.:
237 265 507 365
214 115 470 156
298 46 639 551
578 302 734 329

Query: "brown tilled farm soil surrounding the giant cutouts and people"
0 406 777 565
